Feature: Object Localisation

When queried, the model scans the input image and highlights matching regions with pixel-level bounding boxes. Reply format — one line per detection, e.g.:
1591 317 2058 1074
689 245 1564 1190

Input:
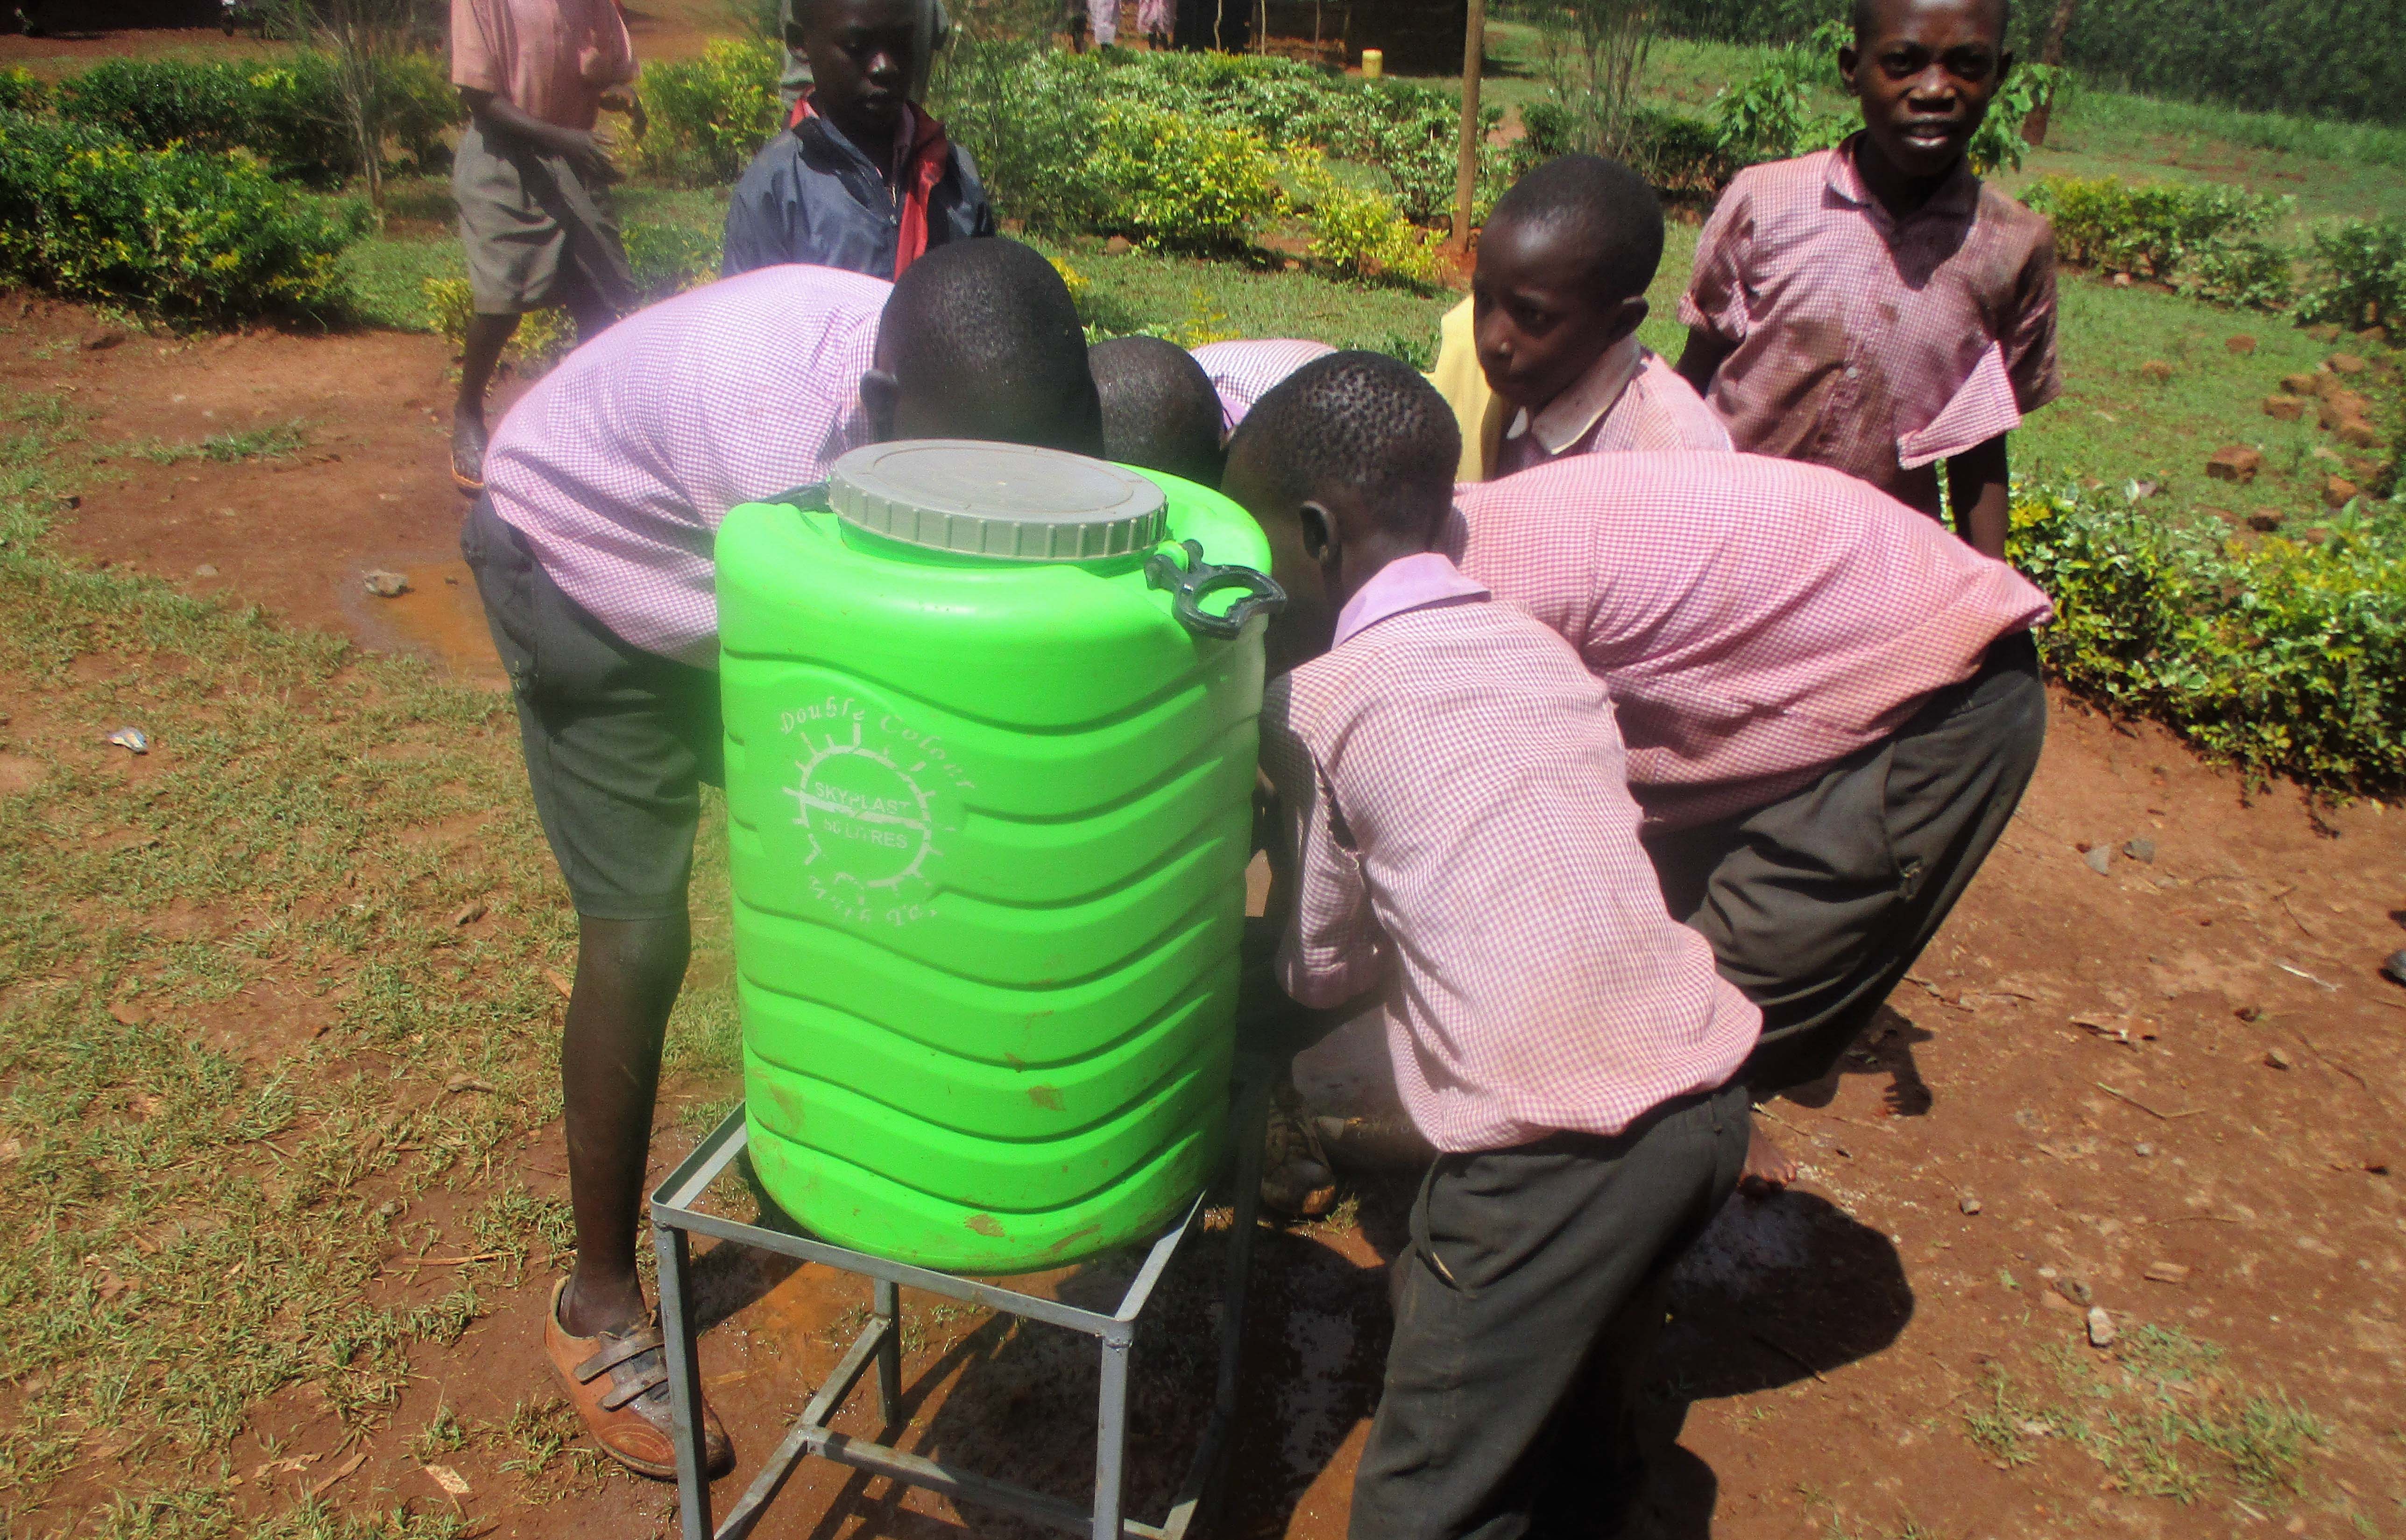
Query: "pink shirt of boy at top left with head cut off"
453 0 635 127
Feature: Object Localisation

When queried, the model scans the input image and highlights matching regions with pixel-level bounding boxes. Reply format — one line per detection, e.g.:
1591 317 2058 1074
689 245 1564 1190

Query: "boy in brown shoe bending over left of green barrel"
460 240 1102 1480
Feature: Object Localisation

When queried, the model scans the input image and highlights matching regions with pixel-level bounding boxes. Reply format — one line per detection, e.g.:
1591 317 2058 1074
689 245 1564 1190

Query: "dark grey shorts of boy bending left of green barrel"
460 498 727 919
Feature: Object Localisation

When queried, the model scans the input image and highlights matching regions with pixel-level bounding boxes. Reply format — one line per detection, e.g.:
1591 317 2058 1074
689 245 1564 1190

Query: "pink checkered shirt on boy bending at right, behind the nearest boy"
1431 455 2055 828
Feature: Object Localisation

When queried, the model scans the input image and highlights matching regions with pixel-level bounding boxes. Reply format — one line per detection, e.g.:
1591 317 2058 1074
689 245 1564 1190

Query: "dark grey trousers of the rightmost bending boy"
1646 633 2047 1095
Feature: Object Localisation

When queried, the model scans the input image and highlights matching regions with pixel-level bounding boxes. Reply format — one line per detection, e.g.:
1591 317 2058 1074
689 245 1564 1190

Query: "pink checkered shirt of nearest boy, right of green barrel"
1261 568 1761 1150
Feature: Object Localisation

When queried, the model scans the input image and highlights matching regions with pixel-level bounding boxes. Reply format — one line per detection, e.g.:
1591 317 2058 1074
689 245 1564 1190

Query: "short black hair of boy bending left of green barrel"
878 236 1095 418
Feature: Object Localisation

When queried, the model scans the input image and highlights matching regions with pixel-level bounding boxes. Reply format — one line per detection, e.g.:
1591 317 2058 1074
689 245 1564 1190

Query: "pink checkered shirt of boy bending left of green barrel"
484 267 892 669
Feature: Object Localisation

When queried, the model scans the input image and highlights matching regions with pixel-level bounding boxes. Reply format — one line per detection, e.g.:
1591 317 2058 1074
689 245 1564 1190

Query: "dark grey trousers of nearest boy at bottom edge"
1347 1085 1747 1540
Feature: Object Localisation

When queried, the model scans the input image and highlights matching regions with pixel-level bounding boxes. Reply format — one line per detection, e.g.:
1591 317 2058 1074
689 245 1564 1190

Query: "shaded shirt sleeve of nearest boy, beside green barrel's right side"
1261 678 1381 1008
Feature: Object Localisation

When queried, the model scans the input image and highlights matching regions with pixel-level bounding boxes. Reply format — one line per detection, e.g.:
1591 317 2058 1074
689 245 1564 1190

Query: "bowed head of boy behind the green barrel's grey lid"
861 238 1102 457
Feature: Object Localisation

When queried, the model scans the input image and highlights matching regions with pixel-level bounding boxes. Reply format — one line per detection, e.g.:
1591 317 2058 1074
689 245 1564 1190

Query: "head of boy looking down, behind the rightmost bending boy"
1470 154 1663 411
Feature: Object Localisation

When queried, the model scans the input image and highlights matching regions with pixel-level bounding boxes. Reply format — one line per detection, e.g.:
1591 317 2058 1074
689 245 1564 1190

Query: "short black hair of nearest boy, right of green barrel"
1227 351 1463 530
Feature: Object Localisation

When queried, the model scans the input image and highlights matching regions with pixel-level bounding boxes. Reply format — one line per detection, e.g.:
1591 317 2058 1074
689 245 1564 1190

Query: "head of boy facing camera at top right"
1838 0 2014 183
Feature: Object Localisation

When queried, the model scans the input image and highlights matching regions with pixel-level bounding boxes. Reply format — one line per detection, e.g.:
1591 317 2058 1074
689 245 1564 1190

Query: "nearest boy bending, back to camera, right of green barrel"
1224 354 1756 1540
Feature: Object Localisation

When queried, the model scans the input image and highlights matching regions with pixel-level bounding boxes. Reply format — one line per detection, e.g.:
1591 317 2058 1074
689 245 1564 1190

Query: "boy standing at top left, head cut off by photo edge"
453 0 640 493
